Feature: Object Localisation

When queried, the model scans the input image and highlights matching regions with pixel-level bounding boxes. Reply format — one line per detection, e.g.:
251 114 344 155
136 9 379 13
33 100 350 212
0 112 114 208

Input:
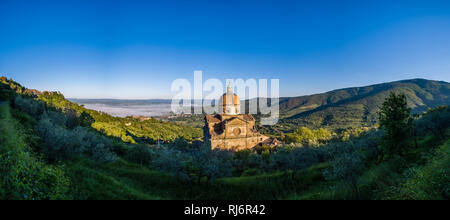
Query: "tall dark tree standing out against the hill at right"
378 92 413 159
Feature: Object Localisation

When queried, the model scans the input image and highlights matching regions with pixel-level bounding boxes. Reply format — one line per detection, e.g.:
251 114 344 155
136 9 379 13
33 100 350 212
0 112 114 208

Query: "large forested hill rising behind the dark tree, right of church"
260 79 450 131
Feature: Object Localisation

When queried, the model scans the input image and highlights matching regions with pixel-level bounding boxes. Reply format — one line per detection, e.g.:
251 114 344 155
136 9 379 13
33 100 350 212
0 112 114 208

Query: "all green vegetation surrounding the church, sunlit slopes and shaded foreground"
0 78 450 199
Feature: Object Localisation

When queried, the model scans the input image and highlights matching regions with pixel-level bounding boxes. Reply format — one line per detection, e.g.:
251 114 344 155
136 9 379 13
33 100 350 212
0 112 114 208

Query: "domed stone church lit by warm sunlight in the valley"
204 85 281 150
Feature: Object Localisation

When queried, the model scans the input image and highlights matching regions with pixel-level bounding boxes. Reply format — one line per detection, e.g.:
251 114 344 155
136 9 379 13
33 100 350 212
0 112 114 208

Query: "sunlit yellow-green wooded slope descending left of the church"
0 77 203 143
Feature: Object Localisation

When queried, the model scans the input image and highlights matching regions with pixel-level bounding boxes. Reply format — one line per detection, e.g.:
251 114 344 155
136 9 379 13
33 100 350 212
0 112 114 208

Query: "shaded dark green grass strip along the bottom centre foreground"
65 160 327 200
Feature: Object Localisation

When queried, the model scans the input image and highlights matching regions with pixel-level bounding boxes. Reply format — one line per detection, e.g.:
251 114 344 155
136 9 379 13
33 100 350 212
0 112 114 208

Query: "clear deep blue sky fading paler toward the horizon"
0 0 450 99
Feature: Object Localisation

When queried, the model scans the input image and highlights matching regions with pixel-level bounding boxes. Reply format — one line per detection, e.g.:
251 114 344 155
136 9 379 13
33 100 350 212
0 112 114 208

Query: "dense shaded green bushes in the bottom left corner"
0 104 69 200
